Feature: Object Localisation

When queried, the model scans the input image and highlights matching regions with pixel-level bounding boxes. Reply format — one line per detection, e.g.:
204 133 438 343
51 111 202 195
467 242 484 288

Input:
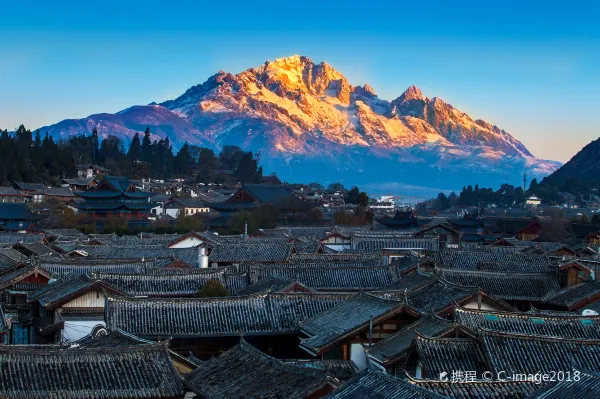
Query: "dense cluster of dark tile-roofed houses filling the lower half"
0 212 600 399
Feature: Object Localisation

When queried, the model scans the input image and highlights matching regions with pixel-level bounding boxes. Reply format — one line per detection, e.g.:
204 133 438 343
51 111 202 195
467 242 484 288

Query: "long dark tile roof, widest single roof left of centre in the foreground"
105 293 348 338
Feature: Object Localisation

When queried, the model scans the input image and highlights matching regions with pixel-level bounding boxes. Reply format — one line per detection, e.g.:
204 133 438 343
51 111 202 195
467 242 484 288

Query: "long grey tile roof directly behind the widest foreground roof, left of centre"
92 268 236 297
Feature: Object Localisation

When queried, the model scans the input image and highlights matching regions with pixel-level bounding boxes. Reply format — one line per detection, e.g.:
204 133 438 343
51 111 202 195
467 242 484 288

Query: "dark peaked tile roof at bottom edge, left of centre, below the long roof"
185 339 329 399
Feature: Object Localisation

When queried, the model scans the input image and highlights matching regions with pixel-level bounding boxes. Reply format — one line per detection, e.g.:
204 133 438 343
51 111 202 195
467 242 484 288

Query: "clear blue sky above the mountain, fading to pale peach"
0 0 600 161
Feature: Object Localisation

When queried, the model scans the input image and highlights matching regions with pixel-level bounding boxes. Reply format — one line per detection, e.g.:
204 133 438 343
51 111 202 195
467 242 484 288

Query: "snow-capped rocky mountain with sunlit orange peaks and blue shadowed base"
41 56 560 189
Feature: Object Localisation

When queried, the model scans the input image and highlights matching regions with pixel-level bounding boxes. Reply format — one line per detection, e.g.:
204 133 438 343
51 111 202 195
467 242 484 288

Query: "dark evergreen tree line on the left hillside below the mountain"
0 125 263 185
